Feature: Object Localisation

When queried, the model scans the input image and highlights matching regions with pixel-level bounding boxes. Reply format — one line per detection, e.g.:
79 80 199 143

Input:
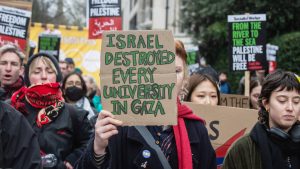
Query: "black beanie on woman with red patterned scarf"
24 53 62 87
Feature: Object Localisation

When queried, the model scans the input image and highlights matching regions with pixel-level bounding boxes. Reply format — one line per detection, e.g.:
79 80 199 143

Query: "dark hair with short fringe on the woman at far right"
258 69 300 125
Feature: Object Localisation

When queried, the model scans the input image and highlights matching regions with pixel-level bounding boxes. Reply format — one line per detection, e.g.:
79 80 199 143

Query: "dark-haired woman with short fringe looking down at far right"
222 70 300 169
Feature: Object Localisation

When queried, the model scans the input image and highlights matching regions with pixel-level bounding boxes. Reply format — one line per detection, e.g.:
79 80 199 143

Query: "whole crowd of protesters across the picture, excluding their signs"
0 40 300 169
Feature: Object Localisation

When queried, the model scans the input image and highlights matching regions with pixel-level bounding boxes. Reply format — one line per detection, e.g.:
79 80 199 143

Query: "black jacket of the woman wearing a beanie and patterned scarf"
26 103 92 169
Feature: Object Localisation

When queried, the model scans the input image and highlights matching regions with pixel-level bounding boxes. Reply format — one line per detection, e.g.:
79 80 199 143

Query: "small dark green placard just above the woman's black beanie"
38 34 61 60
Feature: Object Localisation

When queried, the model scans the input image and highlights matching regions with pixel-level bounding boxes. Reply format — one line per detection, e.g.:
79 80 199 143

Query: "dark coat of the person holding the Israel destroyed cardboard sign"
75 120 217 169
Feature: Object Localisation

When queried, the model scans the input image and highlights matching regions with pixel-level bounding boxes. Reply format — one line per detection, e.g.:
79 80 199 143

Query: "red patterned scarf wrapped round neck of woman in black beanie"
11 83 64 127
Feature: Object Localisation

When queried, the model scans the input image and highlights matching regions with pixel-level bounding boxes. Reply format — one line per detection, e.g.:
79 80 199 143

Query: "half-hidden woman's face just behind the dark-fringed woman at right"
250 80 261 109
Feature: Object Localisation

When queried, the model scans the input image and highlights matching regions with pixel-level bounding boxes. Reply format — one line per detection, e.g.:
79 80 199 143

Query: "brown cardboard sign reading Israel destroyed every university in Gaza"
100 31 177 125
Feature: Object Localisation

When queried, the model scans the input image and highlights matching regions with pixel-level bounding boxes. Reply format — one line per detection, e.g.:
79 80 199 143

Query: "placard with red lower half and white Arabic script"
88 0 122 39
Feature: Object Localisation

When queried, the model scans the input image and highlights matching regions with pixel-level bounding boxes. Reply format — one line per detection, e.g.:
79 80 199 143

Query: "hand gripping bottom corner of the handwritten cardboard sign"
94 110 123 154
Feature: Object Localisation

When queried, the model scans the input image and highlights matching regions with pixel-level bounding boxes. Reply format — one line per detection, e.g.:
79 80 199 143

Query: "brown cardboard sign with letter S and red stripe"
184 102 258 168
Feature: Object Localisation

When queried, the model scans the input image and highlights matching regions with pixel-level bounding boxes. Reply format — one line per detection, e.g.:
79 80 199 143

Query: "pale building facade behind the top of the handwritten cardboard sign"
121 0 198 51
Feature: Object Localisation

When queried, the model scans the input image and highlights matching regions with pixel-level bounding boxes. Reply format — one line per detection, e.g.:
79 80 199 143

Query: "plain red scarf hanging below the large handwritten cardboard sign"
173 99 204 169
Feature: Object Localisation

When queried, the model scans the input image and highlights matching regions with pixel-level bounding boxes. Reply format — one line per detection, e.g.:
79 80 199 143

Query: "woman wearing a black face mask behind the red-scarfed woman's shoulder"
62 72 95 119
